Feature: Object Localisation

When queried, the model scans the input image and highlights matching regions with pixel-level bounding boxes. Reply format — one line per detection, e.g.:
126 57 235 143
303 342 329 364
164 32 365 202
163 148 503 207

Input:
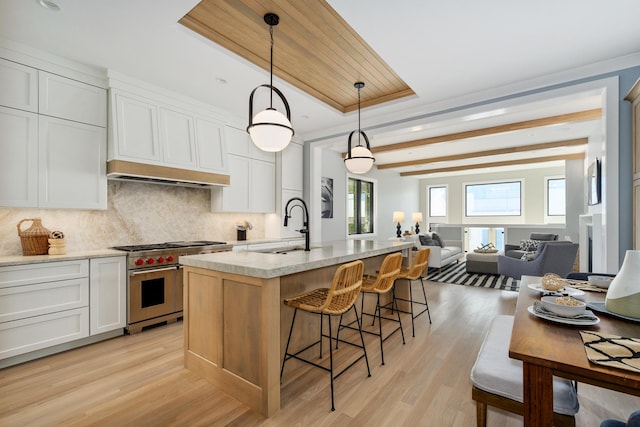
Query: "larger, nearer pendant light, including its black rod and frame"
247 13 294 152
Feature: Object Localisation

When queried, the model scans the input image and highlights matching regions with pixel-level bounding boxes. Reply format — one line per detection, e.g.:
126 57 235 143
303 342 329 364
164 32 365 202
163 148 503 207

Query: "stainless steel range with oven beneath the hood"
112 240 232 334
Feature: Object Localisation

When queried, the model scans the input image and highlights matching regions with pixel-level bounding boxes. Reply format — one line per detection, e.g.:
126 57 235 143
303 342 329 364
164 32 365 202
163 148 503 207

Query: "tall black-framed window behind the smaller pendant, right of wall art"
347 178 374 235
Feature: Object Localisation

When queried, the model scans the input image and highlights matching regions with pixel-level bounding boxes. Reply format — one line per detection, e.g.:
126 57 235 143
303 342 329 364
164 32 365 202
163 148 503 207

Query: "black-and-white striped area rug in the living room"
427 262 519 291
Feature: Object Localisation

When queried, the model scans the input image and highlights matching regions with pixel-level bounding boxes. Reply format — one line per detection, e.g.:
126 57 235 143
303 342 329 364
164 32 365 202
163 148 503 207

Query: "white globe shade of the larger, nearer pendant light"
249 108 293 152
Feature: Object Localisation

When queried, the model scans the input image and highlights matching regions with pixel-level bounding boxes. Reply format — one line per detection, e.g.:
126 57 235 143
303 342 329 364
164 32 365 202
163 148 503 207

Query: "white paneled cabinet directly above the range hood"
108 83 228 174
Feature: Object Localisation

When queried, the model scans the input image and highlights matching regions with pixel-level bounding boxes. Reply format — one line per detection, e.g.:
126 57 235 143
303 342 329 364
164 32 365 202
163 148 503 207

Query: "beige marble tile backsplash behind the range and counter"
0 181 265 256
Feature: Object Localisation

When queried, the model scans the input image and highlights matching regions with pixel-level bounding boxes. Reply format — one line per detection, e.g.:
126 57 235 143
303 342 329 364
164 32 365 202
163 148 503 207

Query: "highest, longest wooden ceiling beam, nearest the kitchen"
362 108 602 157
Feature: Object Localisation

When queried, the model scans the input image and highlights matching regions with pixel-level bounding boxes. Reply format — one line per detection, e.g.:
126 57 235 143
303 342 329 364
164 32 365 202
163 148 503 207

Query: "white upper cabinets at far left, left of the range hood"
0 59 107 209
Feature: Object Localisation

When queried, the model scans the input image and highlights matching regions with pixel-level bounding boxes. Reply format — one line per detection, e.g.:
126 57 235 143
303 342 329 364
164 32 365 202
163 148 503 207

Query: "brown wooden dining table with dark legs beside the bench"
509 276 640 427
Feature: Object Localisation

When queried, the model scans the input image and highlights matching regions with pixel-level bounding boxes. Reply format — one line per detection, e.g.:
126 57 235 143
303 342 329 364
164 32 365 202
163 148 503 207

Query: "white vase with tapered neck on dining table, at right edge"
605 251 640 319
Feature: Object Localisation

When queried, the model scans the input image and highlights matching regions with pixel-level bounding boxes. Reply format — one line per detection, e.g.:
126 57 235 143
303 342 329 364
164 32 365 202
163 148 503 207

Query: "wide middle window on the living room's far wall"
465 181 522 216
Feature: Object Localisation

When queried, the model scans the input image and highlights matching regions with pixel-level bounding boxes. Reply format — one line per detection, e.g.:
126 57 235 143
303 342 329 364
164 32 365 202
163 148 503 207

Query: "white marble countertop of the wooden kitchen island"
180 240 413 279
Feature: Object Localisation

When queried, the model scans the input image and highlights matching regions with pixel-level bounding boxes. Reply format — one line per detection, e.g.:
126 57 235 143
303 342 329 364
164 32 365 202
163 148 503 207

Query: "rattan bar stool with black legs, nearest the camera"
280 261 371 411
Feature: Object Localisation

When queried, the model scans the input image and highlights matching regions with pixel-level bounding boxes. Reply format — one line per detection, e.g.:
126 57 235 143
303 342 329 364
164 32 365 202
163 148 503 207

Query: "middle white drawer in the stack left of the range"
0 278 89 323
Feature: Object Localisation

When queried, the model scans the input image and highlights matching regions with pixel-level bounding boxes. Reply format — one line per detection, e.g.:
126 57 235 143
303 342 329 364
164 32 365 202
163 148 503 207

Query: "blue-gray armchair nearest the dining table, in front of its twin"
498 241 578 280
